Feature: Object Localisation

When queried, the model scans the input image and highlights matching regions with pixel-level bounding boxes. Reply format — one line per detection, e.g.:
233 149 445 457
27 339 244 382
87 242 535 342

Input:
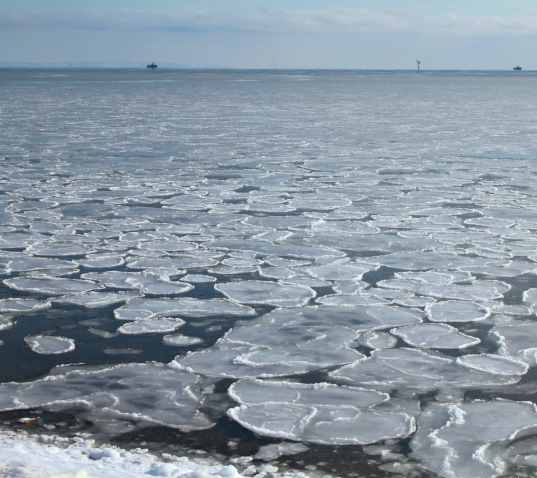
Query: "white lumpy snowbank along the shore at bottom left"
0 431 306 478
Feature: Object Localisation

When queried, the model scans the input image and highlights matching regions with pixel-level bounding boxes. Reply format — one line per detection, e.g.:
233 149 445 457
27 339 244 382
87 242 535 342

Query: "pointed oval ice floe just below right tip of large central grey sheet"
390 324 481 349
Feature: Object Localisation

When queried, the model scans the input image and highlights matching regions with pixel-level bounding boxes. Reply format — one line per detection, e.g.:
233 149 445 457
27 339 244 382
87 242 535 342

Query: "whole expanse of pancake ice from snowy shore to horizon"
0 70 537 478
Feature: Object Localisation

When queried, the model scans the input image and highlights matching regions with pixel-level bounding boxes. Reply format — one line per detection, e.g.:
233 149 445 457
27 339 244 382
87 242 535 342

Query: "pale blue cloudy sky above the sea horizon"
0 0 537 70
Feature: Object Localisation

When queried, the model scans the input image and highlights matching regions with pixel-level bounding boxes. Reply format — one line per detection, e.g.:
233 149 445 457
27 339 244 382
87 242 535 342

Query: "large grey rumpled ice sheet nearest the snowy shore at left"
0 364 213 431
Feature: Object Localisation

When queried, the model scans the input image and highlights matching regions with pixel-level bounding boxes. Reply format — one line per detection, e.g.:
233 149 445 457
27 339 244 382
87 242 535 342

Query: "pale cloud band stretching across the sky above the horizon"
0 5 537 36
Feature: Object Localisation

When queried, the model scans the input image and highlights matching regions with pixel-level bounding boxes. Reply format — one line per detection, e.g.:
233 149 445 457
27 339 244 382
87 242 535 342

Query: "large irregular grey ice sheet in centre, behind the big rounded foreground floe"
174 306 423 378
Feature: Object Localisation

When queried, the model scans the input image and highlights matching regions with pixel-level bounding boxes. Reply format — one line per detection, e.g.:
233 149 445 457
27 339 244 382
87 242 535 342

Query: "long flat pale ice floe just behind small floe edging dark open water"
114 298 256 320
